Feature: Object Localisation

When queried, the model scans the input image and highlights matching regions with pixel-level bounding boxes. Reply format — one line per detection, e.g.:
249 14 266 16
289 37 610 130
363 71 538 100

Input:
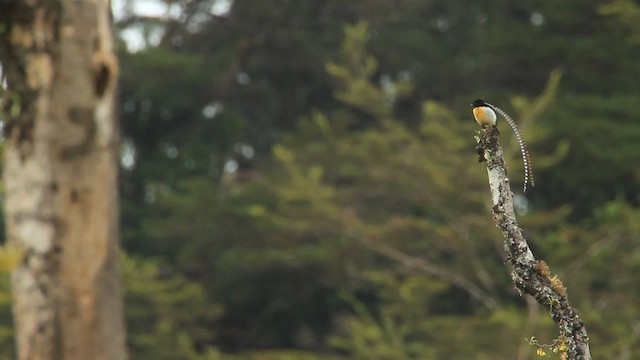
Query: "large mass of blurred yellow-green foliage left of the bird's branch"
138 19 564 359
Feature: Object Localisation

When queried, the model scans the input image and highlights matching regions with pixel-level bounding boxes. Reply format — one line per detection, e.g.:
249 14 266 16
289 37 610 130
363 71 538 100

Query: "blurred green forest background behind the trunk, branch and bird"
0 0 640 360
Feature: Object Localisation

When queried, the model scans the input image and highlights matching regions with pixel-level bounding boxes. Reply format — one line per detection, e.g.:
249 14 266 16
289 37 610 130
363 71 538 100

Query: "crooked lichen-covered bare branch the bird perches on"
478 127 591 360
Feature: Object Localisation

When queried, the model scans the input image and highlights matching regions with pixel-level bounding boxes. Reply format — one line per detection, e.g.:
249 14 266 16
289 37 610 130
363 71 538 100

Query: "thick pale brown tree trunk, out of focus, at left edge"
0 0 126 360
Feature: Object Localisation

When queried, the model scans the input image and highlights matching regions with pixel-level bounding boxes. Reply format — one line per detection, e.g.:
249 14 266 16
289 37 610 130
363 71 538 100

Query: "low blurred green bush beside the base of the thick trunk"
121 256 222 360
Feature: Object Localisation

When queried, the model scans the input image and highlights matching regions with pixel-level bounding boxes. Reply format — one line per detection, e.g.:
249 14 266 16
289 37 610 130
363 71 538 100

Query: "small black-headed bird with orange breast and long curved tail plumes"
471 99 535 192
